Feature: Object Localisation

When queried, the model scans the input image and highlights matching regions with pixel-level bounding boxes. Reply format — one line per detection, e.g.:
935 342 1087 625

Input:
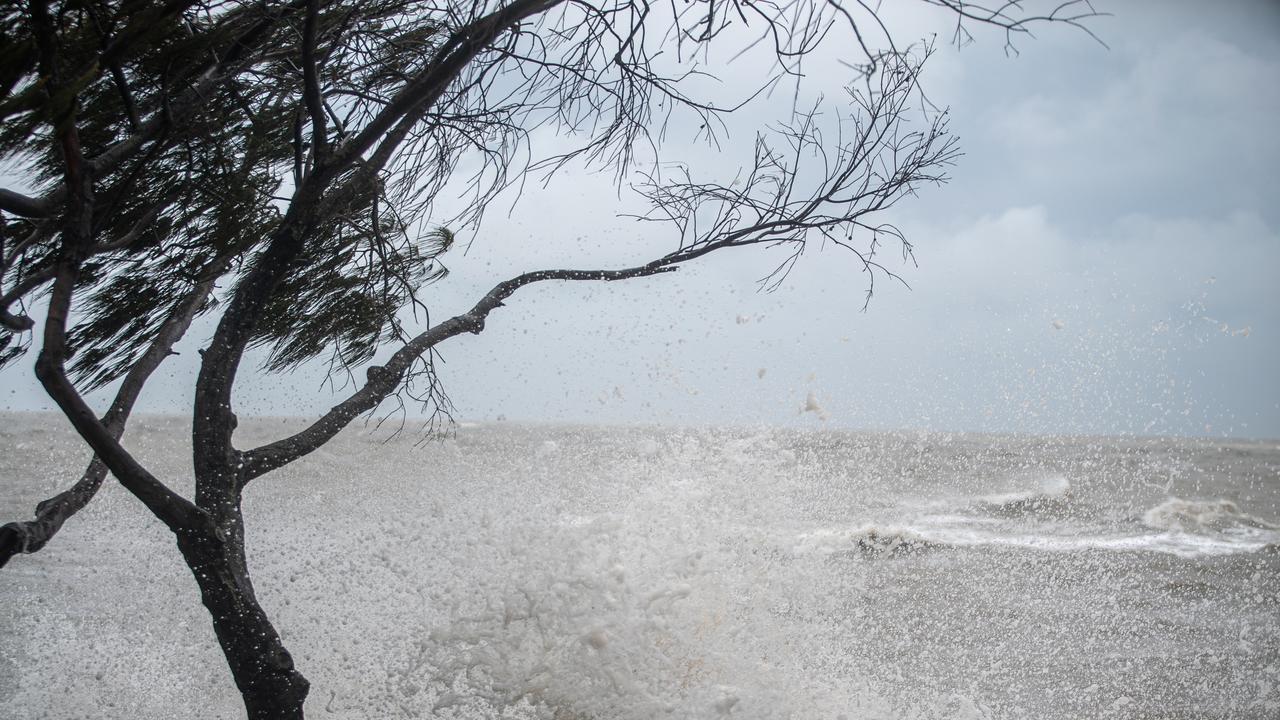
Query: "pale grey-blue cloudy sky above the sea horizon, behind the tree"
0 0 1280 438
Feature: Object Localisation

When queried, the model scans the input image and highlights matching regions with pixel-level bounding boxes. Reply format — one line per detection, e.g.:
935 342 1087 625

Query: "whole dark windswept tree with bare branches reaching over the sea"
0 0 1094 719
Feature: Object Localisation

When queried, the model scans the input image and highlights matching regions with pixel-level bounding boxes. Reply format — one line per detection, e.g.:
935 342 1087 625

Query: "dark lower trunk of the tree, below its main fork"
178 521 310 720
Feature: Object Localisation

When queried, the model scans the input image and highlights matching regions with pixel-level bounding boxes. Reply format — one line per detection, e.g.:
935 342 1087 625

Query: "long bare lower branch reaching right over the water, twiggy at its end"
239 44 955 483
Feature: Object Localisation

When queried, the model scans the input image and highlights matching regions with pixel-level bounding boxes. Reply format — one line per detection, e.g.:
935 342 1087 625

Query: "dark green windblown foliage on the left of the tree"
0 0 452 389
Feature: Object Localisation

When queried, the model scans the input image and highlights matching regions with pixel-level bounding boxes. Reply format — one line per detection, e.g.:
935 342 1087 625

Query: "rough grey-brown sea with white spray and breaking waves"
0 415 1280 720
